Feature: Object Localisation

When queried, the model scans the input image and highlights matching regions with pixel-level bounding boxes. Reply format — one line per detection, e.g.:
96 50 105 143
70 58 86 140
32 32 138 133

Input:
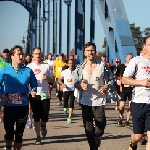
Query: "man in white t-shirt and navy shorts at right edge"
122 36 150 150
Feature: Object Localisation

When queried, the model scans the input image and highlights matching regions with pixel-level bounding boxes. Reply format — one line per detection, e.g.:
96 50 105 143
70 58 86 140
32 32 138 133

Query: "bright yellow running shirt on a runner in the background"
54 60 66 78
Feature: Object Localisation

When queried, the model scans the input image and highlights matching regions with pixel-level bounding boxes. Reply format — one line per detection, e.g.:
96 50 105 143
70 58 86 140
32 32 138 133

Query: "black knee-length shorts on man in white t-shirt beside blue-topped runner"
29 95 50 122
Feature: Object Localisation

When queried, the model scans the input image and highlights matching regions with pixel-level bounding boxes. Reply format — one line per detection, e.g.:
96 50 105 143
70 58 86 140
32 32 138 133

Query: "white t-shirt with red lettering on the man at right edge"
123 56 150 104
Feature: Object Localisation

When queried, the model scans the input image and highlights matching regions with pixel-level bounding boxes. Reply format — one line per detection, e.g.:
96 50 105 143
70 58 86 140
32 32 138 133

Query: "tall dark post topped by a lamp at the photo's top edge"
64 0 72 56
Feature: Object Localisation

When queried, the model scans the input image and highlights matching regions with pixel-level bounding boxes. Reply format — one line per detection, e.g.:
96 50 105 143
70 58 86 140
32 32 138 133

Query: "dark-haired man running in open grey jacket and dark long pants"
74 42 119 150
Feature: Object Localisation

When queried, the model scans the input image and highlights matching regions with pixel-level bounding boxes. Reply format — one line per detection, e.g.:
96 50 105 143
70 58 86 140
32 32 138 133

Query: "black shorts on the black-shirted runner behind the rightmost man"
120 87 132 101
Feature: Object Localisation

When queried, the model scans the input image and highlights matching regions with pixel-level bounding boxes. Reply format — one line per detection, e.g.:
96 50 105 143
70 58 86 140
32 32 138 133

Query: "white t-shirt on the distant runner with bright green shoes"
60 68 74 92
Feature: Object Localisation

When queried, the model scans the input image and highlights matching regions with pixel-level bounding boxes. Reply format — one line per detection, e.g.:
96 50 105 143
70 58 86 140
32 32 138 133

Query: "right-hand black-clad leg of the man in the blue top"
14 106 29 150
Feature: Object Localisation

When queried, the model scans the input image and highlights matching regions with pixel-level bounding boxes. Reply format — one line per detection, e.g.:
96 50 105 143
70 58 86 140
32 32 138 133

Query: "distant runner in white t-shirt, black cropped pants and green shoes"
58 59 75 123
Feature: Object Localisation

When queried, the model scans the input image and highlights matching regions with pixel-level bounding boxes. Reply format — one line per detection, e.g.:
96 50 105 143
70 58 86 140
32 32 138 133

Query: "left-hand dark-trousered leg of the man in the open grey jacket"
81 105 96 150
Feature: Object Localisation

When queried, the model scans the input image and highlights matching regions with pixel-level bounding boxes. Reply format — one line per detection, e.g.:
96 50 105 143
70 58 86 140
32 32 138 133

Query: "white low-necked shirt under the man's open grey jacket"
81 63 106 106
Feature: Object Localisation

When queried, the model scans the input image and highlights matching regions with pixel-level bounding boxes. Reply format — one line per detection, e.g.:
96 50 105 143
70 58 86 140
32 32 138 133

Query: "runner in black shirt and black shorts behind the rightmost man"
116 53 133 127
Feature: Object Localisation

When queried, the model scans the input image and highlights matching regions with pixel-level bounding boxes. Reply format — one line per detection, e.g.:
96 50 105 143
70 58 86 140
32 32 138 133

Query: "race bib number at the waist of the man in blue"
8 94 23 104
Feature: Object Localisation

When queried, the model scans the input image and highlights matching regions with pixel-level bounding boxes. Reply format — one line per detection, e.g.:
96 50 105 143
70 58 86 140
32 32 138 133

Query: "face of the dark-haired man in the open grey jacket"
84 45 96 61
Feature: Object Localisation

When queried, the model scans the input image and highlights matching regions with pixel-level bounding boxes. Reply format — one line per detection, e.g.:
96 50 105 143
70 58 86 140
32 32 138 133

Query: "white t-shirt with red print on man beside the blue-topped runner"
27 62 53 95
